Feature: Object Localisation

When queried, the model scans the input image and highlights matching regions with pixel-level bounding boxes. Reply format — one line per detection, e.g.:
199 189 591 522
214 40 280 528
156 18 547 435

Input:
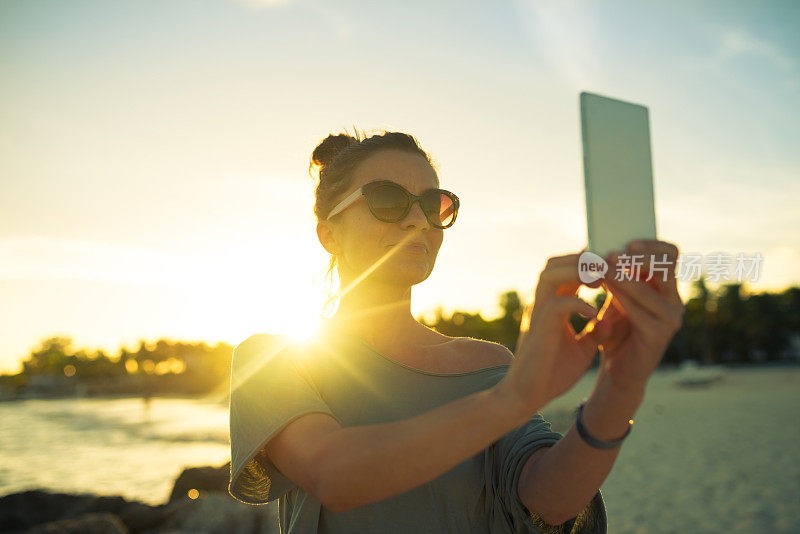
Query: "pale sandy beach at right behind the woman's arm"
542 367 800 533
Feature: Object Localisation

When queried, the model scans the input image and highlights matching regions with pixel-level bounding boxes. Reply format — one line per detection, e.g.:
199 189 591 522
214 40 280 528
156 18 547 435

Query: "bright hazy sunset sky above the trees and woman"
0 0 800 372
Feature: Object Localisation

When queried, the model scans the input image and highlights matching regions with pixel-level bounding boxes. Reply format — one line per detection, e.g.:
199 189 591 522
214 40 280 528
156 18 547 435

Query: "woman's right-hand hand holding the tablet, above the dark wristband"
587 239 684 395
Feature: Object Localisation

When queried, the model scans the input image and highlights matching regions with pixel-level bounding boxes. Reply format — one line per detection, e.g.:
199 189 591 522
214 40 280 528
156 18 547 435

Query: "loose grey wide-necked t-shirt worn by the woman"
228 329 606 534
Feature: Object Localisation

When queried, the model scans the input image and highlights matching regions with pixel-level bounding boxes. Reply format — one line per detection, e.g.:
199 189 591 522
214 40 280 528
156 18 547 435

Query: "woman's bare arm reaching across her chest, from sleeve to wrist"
266 376 526 512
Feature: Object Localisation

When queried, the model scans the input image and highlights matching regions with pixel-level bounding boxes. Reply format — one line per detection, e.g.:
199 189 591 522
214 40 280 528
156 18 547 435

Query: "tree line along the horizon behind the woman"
0 279 800 394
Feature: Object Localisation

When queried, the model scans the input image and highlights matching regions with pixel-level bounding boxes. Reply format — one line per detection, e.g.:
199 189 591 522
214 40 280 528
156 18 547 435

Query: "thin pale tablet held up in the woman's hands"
580 92 657 258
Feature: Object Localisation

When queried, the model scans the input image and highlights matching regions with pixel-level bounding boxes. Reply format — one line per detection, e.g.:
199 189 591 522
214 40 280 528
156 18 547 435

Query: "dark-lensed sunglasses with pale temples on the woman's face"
327 180 460 228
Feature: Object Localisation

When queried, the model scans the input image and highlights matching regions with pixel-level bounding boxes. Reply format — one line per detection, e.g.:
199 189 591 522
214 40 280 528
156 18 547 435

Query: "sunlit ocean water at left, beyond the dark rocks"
0 397 230 504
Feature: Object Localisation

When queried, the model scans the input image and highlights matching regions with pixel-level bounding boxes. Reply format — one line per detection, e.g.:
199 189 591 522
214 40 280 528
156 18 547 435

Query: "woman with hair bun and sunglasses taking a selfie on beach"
229 132 683 534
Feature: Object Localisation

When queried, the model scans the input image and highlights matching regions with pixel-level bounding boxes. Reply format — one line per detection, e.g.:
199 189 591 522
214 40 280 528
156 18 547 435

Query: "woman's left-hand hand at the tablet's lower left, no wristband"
497 253 600 415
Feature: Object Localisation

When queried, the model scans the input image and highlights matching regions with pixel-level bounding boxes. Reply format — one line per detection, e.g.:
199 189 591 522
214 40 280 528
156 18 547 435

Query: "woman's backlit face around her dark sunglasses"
318 149 444 292
